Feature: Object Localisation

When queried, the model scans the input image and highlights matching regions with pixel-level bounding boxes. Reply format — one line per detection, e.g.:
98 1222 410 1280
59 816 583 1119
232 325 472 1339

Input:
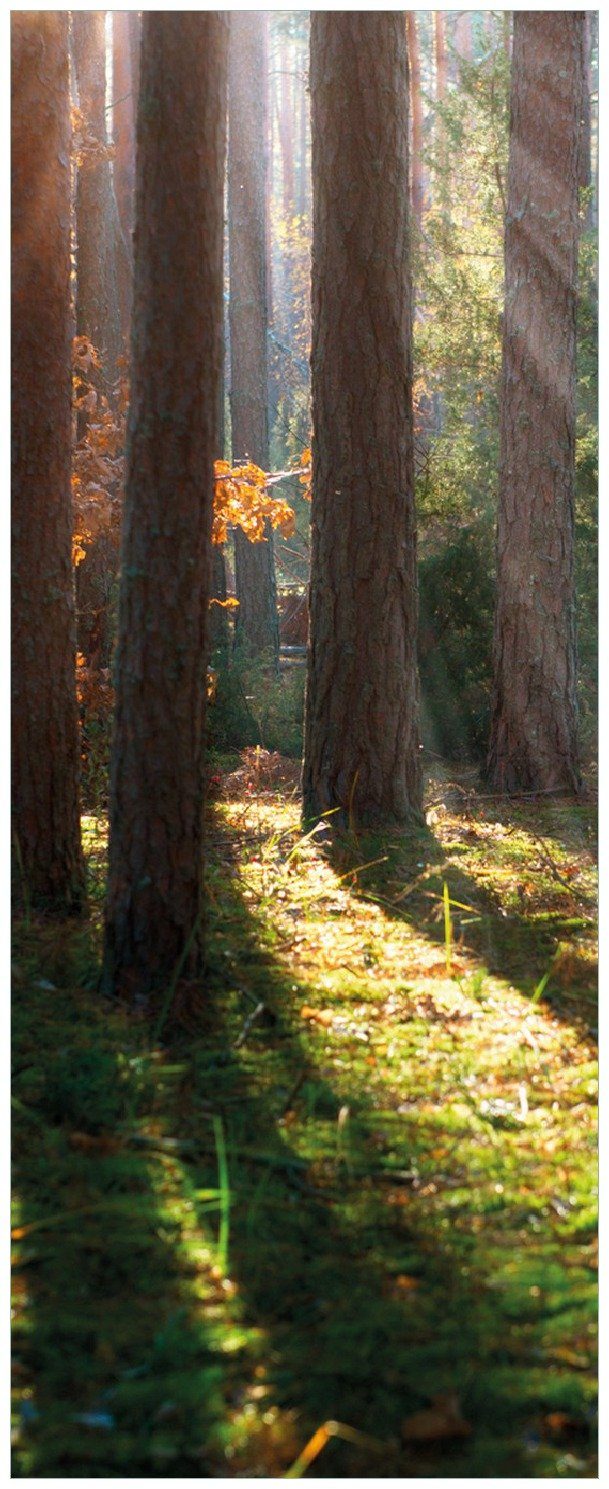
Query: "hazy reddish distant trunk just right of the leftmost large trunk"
71 10 121 393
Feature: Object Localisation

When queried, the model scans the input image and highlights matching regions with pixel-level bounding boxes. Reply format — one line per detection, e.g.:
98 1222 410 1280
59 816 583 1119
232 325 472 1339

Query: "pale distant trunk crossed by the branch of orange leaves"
228 10 278 666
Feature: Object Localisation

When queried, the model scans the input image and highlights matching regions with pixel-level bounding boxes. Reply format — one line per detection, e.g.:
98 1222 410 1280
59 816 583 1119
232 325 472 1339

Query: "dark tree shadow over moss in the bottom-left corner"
12 922 223 1479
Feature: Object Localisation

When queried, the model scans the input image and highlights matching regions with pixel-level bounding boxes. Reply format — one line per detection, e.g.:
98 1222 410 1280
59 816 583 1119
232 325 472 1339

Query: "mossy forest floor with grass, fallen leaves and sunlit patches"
12 750 597 1479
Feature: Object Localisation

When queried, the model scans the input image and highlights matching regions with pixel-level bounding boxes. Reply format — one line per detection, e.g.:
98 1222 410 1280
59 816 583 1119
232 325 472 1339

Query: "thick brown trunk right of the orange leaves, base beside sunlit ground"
304 10 420 825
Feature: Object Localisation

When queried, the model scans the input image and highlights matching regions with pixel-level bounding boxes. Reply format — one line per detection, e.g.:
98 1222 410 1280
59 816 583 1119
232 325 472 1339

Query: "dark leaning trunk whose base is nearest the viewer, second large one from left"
104 10 226 1001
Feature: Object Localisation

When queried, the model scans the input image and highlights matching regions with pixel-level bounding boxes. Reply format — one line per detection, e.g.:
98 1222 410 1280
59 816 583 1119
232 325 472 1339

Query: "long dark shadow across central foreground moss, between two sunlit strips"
166 839 592 1477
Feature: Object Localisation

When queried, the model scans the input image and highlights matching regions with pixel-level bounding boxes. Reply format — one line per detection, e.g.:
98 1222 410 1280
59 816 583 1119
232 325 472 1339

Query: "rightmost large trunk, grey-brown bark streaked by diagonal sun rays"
488 10 584 791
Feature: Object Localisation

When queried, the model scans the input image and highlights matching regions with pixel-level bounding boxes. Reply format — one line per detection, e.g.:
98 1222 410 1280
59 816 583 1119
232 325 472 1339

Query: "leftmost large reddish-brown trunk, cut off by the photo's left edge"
12 10 83 910
